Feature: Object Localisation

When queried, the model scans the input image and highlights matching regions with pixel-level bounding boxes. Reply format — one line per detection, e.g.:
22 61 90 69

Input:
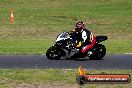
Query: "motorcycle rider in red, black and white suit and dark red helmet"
72 21 96 53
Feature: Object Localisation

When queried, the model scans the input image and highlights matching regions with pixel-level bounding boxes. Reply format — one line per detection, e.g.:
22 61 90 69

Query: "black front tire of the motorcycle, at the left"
46 46 64 60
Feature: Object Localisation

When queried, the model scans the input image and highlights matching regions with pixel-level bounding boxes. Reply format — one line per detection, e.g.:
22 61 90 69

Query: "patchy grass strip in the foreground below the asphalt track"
0 69 132 88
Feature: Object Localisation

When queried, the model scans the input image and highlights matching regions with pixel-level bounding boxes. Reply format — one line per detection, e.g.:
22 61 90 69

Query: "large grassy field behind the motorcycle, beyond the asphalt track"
0 0 132 54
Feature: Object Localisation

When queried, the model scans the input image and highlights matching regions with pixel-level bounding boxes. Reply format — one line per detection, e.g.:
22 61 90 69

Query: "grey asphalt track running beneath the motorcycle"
0 54 132 70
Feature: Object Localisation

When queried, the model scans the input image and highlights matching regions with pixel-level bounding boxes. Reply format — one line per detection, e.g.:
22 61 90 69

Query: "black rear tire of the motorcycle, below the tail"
89 44 106 60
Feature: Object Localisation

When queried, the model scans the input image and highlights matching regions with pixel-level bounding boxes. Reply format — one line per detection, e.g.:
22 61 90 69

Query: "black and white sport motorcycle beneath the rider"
46 32 108 60
